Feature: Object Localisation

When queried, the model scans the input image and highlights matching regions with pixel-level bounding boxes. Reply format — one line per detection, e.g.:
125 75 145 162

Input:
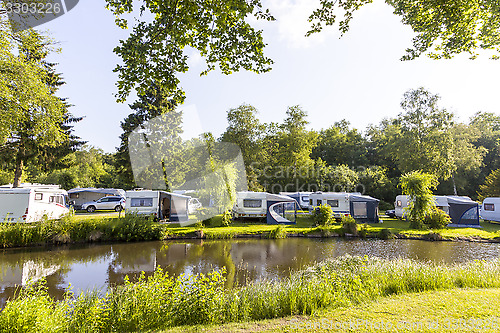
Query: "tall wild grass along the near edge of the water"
0 256 500 332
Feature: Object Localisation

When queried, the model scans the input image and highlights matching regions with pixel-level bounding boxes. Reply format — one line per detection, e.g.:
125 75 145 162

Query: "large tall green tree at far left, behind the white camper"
0 29 74 187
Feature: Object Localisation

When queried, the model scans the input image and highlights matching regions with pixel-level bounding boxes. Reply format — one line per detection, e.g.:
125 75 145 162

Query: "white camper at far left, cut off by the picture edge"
0 184 69 222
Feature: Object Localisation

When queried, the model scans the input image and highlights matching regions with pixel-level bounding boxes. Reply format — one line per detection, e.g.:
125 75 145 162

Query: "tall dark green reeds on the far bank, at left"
0 214 164 248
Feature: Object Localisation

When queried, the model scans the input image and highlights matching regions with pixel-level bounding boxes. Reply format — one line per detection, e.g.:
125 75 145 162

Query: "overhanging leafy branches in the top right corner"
308 0 500 60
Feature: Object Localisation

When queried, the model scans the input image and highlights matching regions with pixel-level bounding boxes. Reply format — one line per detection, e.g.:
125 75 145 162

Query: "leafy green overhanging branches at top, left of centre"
102 0 273 103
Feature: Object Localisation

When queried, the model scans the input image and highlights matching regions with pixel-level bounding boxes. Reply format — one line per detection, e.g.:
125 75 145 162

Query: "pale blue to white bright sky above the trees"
39 0 500 152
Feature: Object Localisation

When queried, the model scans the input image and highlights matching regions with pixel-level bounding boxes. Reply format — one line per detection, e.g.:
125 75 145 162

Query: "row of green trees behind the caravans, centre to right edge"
220 88 500 208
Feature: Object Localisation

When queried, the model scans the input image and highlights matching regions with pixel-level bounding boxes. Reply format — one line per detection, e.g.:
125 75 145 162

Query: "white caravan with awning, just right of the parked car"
125 190 191 222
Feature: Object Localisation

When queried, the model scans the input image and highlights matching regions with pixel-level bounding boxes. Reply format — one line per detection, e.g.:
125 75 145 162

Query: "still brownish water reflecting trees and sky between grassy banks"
0 238 500 306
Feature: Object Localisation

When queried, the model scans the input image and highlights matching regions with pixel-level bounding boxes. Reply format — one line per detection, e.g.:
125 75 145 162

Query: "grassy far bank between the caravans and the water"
0 213 500 248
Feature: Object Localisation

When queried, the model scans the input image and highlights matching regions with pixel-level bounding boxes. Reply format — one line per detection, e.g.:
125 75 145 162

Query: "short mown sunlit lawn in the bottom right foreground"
159 288 500 332
